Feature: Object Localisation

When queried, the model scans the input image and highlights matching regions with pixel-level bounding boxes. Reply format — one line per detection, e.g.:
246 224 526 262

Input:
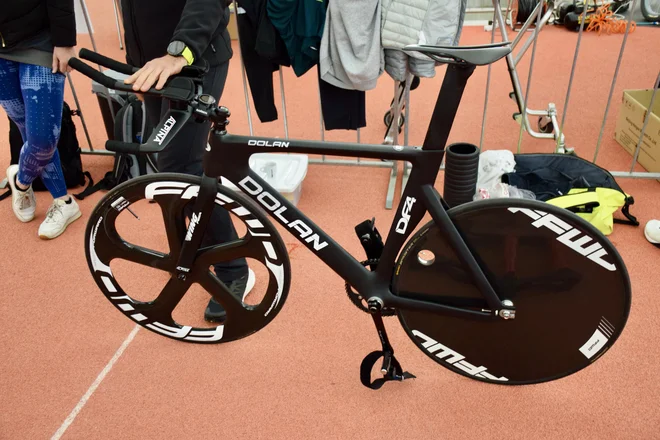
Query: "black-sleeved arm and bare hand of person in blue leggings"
45 0 77 73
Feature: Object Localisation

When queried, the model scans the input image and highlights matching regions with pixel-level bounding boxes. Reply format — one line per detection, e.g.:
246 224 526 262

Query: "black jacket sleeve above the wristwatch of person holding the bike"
171 0 228 60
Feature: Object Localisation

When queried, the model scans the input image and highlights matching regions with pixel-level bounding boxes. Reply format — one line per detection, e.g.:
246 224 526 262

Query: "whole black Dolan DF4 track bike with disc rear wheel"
70 43 631 388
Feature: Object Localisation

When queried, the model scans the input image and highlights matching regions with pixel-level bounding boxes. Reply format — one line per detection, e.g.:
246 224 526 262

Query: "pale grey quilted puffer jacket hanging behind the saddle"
381 0 467 81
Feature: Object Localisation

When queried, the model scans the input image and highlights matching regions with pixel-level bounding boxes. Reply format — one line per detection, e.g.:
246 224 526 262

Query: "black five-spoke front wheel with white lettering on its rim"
85 173 291 343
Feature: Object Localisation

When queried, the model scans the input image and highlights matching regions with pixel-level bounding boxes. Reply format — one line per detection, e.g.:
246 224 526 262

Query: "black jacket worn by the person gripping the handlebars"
121 0 232 67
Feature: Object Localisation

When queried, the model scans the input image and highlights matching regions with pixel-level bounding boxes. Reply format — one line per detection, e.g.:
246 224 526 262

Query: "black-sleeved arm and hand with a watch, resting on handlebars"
124 0 227 92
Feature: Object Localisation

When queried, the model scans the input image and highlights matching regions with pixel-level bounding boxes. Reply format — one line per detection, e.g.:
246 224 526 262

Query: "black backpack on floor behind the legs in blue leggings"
0 102 93 200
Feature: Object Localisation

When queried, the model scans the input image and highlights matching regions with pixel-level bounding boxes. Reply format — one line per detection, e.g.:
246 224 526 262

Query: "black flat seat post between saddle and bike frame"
422 64 476 150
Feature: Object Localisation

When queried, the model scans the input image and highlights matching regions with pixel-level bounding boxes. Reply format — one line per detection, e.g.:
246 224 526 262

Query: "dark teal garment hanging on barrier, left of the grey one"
266 0 328 77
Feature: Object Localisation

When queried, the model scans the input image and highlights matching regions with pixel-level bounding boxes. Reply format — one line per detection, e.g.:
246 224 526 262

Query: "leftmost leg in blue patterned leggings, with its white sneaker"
0 58 36 223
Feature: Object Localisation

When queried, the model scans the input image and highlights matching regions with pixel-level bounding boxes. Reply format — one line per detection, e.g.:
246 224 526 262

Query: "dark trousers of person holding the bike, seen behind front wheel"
144 62 248 283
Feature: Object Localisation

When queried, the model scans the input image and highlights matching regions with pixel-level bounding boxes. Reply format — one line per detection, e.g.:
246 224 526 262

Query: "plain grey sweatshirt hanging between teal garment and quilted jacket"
319 0 384 90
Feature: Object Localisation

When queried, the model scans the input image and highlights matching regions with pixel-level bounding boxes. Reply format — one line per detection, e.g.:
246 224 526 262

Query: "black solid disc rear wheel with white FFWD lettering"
392 199 631 385
